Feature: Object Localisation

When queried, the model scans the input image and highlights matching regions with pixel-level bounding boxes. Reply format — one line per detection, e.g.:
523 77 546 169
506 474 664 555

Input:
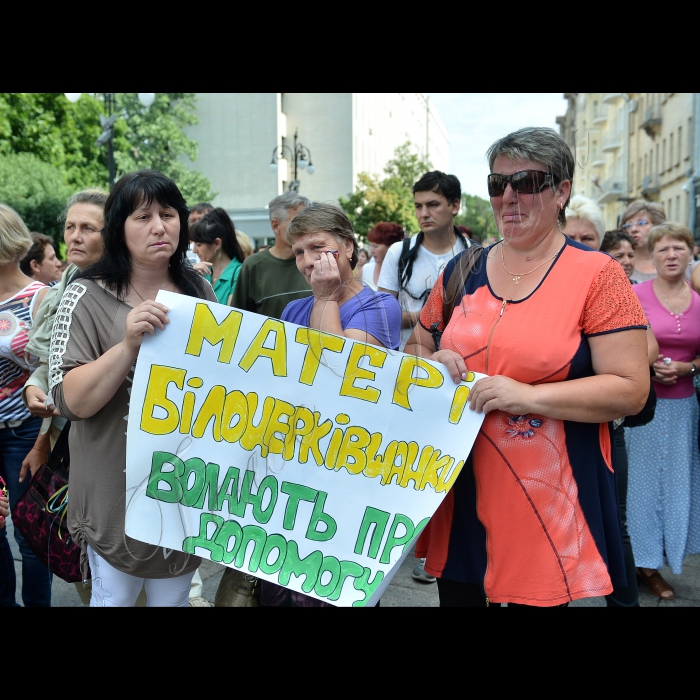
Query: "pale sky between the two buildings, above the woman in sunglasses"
429 92 566 199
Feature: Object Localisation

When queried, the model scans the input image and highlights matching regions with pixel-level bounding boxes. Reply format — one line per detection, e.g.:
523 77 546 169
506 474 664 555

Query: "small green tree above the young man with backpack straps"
338 142 432 240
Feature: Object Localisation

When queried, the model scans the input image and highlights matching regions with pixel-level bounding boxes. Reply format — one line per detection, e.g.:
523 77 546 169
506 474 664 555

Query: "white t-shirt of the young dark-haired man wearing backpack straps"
378 236 471 349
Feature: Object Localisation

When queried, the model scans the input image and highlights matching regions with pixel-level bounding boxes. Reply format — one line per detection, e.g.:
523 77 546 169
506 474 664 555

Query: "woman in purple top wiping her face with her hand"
259 203 401 608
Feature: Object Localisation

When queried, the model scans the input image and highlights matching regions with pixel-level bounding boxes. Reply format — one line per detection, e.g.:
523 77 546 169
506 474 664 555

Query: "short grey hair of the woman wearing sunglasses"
486 126 576 227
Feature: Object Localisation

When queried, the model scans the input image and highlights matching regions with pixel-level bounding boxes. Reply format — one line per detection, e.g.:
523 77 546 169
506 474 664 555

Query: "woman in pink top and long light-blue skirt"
626 222 700 600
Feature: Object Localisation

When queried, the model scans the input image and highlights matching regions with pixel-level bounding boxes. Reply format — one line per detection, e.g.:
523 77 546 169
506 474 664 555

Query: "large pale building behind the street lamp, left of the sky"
187 93 449 244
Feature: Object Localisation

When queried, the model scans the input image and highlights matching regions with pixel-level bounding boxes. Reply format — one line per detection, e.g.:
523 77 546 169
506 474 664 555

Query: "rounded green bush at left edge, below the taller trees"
0 153 71 245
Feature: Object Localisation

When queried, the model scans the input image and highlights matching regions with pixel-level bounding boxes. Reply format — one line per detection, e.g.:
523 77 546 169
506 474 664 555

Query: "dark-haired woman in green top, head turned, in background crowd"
190 207 245 306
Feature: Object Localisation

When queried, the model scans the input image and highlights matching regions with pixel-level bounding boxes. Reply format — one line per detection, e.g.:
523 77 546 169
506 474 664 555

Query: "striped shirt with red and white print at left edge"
0 282 46 422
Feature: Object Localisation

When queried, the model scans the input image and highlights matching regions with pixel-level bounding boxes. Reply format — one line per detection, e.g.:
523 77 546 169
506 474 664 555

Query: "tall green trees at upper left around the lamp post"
0 93 216 204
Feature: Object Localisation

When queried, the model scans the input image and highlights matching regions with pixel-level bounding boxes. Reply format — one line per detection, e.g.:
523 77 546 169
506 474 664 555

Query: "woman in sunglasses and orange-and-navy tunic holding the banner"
405 128 649 606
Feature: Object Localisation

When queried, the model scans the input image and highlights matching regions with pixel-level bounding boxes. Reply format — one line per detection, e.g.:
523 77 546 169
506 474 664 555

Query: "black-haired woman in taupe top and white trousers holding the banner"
49 170 216 607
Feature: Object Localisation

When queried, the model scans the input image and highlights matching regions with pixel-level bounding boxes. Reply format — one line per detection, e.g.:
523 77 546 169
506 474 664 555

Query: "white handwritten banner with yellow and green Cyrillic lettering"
126 291 483 606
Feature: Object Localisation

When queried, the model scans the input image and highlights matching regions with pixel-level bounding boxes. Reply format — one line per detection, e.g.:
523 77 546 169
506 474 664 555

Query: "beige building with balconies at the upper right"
558 93 697 229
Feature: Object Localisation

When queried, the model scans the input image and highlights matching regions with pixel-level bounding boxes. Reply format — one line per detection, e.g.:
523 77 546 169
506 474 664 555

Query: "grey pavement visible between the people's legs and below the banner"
7 520 700 608
